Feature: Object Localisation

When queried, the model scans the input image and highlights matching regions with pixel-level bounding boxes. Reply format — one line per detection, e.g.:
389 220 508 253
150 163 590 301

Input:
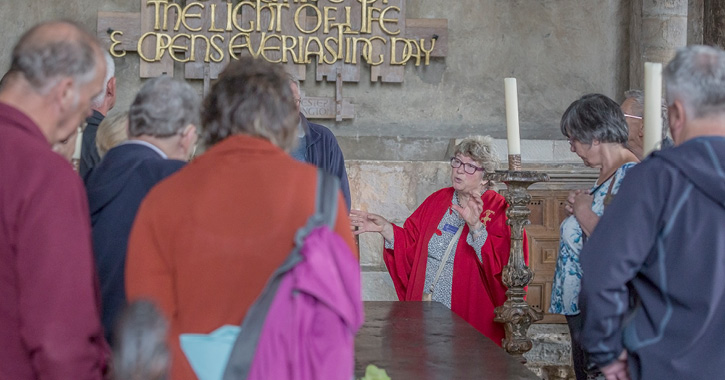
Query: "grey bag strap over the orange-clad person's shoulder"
222 169 340 380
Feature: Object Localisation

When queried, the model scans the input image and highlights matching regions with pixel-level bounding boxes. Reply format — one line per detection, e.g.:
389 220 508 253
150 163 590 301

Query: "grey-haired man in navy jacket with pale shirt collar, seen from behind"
85 76 200 342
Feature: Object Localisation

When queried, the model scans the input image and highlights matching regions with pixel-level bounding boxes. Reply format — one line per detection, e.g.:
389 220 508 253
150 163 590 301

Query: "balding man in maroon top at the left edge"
0 21 109 380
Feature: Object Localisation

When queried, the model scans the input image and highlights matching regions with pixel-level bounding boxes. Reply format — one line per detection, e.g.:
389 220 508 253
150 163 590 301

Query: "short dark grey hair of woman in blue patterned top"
561 94 629 145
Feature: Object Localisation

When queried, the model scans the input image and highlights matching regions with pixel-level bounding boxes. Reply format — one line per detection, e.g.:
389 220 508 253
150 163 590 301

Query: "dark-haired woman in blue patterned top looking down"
549 94 639 380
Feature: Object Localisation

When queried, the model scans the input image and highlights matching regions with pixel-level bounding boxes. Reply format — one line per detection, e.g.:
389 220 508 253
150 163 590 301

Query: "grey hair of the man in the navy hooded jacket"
663 45 725 119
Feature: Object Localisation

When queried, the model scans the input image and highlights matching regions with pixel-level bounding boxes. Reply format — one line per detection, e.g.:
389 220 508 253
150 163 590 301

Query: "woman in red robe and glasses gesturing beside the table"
350 137 528 346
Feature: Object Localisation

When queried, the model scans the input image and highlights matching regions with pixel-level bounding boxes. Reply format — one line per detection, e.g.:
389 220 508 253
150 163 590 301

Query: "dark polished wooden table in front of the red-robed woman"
355 301 538 380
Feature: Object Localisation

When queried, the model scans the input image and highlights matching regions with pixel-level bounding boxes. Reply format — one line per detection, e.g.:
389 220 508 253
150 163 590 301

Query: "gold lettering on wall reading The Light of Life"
114 0 437 66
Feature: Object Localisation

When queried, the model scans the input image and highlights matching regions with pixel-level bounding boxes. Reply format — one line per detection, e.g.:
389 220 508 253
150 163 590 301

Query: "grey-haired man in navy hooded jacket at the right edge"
579 46 725 379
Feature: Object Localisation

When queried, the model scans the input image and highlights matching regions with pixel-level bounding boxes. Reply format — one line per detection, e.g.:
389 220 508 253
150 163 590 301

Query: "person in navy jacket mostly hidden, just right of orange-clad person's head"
289 75 351 210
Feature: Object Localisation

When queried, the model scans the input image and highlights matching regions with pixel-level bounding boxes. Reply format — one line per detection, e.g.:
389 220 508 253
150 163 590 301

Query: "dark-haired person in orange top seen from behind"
126 58 357 380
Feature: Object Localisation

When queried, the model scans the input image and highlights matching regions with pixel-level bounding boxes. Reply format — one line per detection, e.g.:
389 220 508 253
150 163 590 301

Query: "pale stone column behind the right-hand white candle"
629 0 688 89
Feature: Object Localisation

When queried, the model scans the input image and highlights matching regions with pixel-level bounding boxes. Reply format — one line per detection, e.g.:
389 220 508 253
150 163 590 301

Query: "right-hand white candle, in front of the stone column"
642 62 662 156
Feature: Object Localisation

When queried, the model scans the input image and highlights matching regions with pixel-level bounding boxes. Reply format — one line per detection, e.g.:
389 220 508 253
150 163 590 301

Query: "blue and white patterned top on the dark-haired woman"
549 162 636 315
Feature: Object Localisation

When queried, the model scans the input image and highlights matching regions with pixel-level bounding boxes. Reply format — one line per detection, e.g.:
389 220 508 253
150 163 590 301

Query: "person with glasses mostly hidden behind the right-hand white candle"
620 90 672 161
